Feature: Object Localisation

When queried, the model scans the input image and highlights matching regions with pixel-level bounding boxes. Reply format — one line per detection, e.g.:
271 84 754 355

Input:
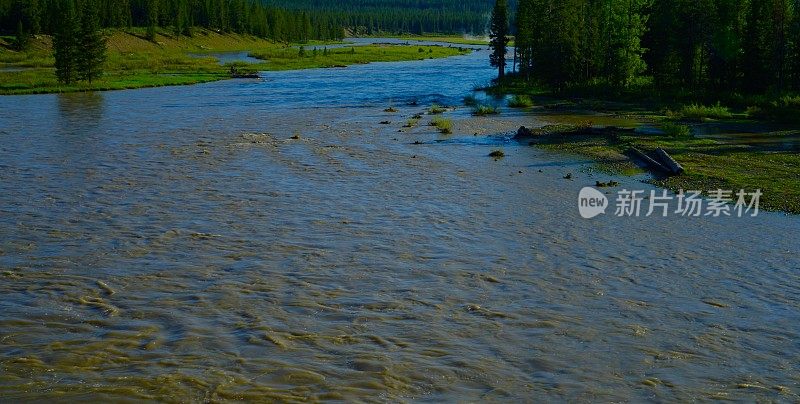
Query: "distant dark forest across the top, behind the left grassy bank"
0 0 491 42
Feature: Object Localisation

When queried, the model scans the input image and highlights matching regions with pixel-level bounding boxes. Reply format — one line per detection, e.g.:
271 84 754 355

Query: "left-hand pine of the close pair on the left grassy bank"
53 0 80 84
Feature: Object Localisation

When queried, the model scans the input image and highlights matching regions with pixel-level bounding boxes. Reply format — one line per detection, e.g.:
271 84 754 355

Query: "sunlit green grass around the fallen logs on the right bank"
536 128 800 213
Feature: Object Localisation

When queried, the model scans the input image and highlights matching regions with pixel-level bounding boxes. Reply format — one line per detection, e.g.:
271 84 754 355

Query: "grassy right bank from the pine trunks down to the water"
486 79 800 213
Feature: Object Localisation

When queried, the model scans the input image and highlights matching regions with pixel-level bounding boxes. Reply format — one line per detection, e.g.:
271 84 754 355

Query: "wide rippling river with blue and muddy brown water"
0 41 800 401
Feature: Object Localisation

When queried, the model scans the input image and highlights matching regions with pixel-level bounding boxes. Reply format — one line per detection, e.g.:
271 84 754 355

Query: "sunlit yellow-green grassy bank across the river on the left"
0 28 469 95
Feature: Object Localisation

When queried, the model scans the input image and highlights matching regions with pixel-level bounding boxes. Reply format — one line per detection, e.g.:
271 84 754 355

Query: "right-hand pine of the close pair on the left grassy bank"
76 0 106 83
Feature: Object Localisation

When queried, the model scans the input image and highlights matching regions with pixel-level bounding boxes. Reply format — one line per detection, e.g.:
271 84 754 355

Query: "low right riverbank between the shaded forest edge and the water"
460 92 800 214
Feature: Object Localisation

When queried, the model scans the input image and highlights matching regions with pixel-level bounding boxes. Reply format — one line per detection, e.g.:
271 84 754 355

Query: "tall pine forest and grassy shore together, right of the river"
486 0 800 213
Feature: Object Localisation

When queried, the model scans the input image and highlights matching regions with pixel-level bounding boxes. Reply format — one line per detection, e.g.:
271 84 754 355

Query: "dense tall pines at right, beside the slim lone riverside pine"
515 0 800 94
